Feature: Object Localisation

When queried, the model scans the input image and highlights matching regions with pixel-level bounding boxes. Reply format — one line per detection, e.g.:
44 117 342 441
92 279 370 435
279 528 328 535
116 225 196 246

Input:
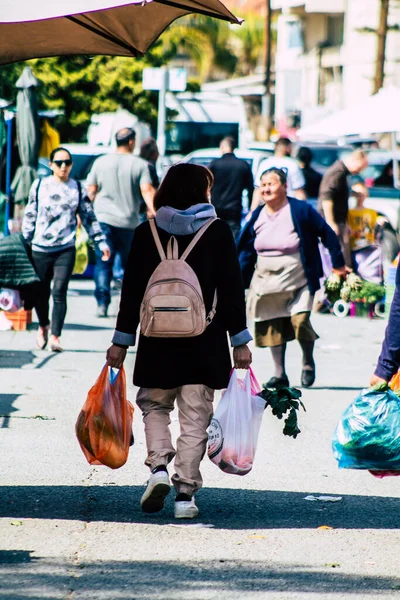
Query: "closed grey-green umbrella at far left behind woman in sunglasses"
11 67 39 204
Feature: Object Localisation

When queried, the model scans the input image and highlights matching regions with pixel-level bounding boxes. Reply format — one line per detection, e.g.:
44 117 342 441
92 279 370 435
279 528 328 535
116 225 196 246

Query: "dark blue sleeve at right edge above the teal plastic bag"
375 265 400 381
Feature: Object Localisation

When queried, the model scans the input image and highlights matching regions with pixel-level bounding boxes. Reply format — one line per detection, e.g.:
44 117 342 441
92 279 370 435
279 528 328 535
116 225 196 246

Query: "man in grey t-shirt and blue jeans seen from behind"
87 127 155 317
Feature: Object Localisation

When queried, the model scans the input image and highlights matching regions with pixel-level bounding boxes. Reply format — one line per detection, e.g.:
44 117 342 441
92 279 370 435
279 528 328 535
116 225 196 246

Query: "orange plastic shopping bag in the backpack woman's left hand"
75 365 134 469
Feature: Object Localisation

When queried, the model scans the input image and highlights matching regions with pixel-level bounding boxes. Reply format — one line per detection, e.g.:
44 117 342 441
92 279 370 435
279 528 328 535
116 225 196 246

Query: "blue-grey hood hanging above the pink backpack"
156 202 217 235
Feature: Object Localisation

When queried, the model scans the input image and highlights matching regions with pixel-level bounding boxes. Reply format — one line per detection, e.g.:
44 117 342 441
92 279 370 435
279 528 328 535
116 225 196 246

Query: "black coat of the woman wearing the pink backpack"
116 219 246 389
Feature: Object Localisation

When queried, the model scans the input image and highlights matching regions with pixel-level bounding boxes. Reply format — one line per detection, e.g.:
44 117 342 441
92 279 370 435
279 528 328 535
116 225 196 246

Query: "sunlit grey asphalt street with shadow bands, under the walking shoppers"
0 281 400 600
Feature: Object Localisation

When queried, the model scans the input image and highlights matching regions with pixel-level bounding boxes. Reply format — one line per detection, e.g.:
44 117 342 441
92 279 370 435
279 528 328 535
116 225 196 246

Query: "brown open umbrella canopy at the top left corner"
0 0 240 64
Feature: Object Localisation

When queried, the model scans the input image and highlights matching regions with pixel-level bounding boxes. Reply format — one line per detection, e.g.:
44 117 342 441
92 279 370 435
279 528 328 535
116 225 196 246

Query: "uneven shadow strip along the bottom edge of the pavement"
0 557 400 600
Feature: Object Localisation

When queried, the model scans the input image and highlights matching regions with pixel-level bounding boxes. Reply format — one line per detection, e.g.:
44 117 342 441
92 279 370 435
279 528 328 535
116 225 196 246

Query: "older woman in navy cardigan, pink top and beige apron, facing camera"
238 168 346 387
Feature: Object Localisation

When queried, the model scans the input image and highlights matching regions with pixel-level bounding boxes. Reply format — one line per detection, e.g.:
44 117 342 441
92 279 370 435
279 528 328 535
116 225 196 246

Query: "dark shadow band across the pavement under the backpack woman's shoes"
0 485 400 530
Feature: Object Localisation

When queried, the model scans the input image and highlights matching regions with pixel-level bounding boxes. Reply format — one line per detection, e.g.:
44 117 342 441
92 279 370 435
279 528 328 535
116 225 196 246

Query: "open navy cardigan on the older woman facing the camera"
237 198 344 295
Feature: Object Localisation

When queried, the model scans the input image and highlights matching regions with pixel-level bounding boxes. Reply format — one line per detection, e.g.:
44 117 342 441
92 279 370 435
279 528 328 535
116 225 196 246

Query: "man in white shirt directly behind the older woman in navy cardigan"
251 137 307 211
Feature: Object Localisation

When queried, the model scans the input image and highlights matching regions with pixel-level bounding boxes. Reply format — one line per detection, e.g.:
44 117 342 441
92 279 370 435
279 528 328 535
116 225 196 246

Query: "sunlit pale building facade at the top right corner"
271 0 400 125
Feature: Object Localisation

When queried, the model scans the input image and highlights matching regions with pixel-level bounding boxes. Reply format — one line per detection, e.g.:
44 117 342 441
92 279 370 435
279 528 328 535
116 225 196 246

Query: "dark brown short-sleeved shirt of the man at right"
318 160 350 223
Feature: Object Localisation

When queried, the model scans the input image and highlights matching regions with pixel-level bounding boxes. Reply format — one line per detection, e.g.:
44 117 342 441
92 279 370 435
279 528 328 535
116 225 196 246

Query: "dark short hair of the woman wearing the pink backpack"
154 163 214 210
